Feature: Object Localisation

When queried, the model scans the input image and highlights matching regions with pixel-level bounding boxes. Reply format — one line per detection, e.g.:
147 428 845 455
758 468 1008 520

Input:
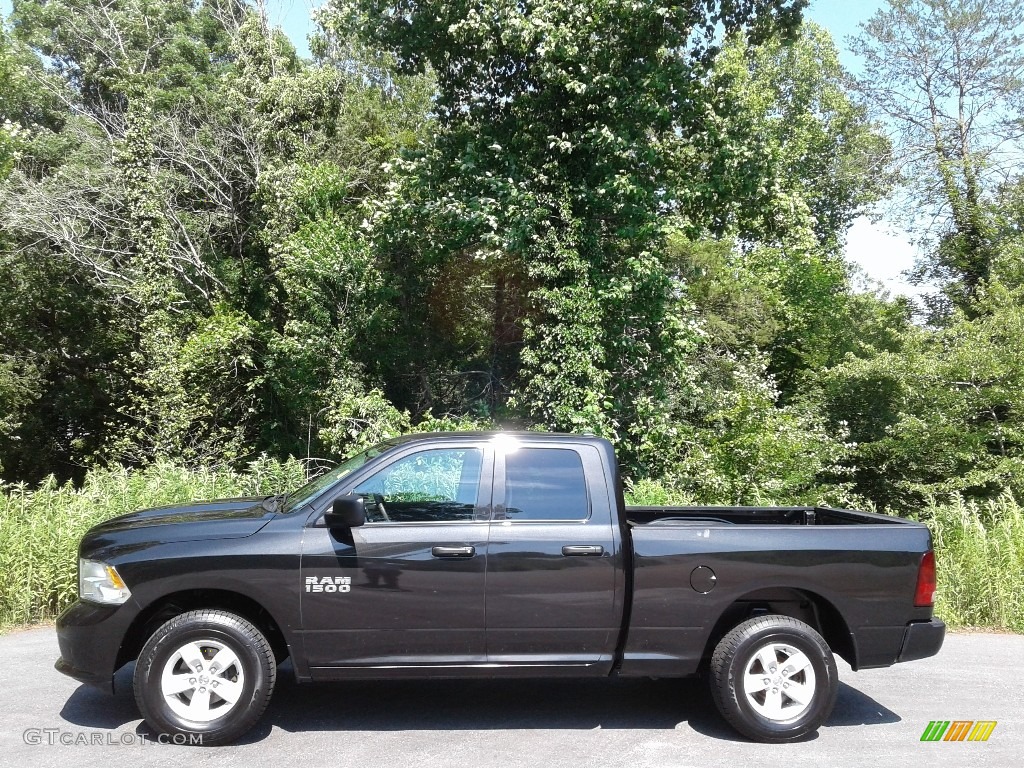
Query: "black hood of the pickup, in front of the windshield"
81 497 275 554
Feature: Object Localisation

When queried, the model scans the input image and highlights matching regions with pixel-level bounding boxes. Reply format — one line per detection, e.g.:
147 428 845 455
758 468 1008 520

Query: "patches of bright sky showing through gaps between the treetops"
0 0 920 295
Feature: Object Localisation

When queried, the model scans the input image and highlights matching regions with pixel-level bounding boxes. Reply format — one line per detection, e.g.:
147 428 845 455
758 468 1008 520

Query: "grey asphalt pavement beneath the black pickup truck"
0 627 1024 768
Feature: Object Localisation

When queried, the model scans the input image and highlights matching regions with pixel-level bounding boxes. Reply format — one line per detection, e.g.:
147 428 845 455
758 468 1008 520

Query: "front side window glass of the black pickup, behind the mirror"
354 449 483 522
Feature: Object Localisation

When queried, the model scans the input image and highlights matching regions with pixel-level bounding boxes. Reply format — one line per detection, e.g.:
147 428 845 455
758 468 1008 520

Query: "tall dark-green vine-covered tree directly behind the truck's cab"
334 0 804 473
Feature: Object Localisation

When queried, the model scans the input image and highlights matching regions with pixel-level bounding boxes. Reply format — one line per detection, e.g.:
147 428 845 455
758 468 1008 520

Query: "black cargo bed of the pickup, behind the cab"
623 507 931 676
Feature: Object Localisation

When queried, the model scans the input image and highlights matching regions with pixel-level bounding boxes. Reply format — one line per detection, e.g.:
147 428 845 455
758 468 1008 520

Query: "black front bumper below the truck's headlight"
53 600 133 693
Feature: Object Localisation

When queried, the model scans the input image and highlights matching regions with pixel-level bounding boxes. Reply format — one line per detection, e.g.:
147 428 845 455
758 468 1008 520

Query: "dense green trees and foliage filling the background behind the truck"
0 0 1024 528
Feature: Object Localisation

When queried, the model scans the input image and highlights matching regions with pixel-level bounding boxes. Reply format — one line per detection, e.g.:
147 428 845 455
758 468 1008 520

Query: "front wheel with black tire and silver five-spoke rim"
134 610 278 745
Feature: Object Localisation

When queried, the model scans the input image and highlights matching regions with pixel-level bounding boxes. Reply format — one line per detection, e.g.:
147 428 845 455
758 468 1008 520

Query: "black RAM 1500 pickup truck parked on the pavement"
56 432 945 744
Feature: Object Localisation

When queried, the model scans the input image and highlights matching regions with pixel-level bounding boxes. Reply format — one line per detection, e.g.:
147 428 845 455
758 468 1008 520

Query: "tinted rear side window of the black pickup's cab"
505 449 590 520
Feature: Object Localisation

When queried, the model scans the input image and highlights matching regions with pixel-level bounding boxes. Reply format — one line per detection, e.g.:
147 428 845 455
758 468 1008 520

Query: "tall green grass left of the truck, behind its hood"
0 459 305 628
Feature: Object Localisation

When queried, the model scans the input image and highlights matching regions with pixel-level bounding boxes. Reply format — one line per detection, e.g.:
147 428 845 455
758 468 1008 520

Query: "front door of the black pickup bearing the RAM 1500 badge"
302 444 490 679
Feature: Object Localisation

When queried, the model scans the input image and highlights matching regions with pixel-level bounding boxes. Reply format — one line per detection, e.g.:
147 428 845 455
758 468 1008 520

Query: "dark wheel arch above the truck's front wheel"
115 588 291 669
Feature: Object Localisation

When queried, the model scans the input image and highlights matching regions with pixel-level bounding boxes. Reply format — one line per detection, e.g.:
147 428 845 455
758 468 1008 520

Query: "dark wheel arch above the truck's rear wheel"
702 587 857 670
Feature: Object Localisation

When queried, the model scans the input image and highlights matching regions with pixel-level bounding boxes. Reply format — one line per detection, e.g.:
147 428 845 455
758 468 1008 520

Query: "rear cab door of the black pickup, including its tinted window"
486 439 624 666
